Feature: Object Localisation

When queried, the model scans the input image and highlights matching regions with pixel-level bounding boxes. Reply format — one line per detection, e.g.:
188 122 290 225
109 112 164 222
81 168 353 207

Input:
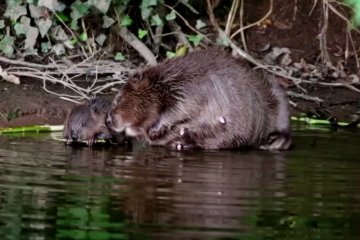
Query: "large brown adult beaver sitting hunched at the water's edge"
107 49 291 149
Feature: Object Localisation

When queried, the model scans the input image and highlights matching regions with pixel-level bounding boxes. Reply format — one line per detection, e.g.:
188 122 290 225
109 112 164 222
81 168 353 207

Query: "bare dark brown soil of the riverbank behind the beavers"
0 0 360 128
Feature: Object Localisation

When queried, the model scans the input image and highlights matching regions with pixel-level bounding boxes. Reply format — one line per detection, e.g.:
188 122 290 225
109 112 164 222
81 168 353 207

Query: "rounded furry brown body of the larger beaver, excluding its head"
146 50 290 149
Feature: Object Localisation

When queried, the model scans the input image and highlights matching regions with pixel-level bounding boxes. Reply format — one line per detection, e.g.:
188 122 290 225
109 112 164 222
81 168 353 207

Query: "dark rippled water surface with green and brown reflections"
0 126 360 240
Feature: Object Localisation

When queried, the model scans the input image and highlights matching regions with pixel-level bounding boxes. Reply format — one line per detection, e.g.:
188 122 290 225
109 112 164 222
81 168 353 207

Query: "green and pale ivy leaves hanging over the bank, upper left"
0 0 206 60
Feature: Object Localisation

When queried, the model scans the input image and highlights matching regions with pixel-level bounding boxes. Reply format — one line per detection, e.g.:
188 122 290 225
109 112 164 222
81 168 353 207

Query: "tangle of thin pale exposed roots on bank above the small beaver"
0 55 134 102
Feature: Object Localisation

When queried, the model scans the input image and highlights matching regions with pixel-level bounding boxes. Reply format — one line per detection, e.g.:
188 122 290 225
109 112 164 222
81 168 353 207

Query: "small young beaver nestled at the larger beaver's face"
63 97 125 146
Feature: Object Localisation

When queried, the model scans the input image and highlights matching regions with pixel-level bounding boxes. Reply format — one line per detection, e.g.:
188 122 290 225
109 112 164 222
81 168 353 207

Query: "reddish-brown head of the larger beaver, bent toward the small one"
106 73 161 137
